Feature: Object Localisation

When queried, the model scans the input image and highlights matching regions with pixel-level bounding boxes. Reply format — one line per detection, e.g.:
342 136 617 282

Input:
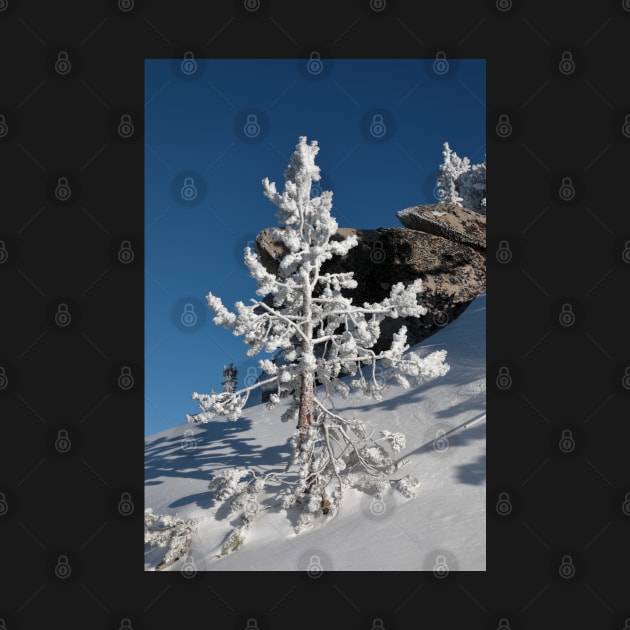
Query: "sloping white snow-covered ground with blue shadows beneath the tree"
145 295 486 576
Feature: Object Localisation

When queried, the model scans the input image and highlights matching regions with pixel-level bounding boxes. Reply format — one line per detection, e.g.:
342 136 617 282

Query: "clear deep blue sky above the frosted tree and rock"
145 55 486 435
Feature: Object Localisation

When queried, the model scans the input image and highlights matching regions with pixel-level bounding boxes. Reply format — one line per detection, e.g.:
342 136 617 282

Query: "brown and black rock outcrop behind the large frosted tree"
255 204 486 352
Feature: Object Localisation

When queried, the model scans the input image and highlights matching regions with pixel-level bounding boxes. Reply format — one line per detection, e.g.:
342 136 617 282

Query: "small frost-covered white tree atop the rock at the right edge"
437 142 486 214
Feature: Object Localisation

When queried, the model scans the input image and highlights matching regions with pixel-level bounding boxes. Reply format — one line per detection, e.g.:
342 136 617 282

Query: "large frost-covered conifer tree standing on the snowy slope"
187 136 449 553
